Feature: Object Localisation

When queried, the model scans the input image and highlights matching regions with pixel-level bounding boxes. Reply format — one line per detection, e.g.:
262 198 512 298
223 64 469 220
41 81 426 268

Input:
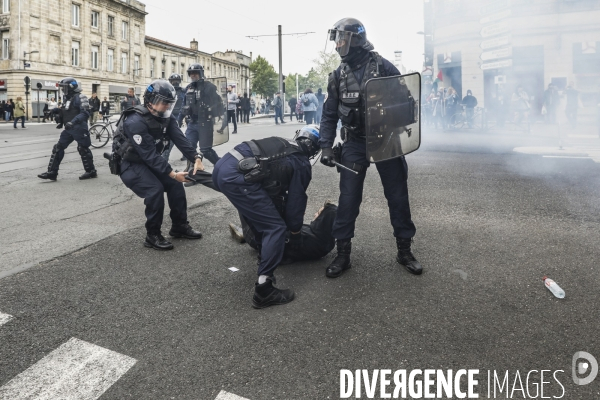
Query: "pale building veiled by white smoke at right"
424 0 600 115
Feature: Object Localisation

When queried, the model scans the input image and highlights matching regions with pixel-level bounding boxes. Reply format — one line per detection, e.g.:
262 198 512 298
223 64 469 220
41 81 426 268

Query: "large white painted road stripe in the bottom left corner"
0 338 136 400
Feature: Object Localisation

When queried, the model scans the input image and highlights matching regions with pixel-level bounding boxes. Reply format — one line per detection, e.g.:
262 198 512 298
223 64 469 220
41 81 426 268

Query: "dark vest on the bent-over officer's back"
244 137 304 196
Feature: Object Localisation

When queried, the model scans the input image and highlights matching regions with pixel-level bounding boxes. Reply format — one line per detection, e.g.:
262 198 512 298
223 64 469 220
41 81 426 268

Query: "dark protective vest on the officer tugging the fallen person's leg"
113 106 171 163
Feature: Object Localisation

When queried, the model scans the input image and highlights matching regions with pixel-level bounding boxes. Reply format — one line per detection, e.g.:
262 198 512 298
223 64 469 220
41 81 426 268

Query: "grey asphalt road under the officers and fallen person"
0 121 600 400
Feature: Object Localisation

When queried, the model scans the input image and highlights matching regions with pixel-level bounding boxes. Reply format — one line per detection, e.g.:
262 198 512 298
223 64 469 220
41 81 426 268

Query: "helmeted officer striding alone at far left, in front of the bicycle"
38 77 98 181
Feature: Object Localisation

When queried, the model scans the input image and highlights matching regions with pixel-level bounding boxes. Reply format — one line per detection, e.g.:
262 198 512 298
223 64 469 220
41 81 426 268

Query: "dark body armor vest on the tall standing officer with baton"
337 51 382 136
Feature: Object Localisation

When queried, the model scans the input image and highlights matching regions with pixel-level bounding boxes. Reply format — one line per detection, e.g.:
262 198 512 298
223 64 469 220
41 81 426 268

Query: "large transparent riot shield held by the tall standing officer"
365 72 421 162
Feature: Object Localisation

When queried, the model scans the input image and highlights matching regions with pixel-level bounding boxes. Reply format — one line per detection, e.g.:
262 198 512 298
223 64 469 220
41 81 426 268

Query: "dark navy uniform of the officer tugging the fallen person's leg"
113 106 202 242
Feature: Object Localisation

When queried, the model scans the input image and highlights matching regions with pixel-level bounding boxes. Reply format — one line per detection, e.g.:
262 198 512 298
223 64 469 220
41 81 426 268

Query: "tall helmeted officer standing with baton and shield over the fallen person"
320 18 423 278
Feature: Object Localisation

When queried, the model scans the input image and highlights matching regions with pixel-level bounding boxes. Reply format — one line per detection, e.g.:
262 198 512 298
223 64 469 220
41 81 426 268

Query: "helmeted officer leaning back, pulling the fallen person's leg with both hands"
111 79 204 250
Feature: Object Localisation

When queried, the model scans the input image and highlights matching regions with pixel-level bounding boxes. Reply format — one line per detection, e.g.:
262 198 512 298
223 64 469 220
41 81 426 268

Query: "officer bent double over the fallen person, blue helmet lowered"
213 125 319 308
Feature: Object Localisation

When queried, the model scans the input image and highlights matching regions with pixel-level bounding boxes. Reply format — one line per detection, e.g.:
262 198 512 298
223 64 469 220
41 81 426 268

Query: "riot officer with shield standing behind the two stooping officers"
182 64 223 164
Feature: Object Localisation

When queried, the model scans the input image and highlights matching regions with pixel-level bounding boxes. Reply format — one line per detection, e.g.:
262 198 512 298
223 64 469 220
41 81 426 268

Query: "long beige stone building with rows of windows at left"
0 0 249 116
